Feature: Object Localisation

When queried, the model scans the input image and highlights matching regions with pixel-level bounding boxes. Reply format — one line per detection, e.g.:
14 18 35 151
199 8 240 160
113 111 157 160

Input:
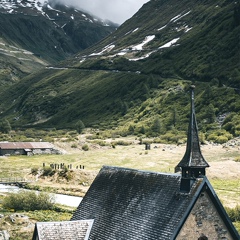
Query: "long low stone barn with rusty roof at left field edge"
0 142 56 156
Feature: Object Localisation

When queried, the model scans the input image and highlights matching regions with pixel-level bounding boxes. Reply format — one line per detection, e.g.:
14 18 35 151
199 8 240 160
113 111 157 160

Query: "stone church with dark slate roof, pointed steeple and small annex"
32 86 240 240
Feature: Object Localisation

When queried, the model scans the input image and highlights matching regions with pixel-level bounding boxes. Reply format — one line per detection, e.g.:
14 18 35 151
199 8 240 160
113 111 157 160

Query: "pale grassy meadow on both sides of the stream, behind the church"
0 135 240 239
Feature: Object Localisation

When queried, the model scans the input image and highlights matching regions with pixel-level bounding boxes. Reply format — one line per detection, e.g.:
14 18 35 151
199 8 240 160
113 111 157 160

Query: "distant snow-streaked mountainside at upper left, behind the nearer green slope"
0 0 117 85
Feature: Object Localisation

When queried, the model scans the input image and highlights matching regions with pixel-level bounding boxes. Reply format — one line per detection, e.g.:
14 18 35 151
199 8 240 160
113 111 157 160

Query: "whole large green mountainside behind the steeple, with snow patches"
0 0 240 142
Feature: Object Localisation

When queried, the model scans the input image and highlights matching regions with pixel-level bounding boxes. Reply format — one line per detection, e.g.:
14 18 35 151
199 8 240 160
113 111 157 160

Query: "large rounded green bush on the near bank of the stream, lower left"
2 191 54 211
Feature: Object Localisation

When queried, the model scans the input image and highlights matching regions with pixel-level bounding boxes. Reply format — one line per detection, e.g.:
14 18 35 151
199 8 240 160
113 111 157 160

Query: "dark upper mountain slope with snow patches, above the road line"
70 0 240 85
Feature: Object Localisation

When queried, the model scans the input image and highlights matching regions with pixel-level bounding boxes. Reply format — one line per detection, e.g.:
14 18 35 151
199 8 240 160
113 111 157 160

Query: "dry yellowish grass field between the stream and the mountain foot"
0 138 240 207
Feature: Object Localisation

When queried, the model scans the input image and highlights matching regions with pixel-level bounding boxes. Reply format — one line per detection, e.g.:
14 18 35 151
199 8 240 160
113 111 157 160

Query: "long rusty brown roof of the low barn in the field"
0 142 53 149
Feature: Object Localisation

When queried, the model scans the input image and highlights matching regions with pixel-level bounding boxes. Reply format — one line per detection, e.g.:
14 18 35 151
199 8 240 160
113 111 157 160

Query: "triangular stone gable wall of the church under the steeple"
176 192 233 240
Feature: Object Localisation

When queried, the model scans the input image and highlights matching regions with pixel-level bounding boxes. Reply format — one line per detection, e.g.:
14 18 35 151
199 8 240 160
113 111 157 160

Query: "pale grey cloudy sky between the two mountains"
46 0 149 24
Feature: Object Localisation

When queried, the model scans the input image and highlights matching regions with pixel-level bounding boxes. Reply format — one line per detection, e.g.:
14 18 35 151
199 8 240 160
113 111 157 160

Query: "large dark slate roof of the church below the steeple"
72 166 202 240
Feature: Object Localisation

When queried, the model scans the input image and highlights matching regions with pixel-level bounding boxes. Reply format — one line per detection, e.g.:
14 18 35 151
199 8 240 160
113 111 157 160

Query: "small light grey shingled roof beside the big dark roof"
32 220 94 240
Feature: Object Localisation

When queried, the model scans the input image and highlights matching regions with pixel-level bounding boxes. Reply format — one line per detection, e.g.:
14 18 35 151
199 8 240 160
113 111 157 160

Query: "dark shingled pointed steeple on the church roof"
176 85 209 192
